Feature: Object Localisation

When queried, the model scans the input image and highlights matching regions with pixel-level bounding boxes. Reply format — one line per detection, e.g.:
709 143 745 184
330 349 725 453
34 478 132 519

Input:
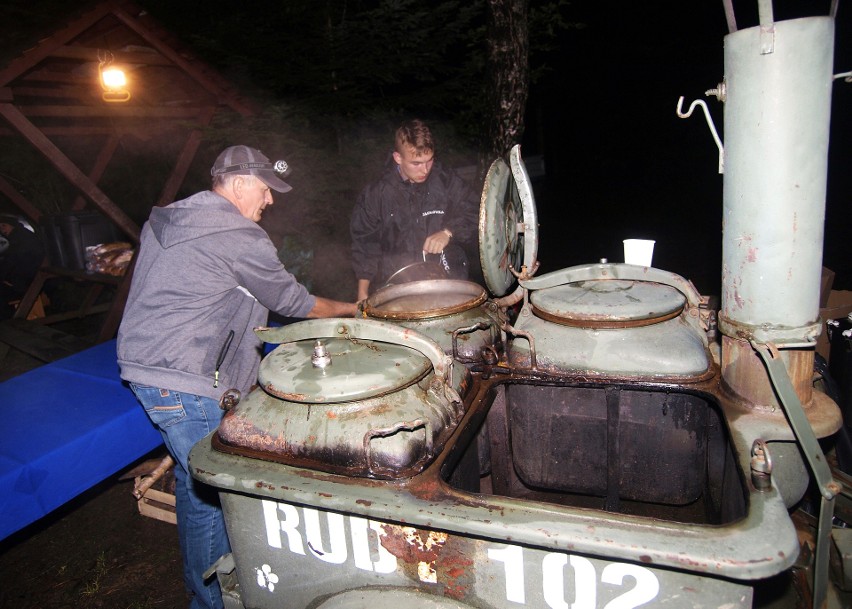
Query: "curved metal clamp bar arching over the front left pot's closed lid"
254 318 452 384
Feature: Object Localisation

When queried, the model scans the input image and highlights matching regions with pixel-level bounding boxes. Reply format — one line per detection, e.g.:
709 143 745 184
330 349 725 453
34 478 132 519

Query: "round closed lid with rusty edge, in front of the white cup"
530 279 686 328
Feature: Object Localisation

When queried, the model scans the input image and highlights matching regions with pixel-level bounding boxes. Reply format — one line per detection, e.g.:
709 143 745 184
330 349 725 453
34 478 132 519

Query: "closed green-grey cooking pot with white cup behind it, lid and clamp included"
509 263 712 381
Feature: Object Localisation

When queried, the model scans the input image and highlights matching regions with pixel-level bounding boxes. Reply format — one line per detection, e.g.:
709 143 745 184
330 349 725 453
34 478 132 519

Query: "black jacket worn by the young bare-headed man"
350 162 479 288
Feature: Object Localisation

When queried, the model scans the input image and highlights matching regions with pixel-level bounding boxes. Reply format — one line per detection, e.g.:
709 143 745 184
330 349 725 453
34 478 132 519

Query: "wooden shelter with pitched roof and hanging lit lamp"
0 0 253 356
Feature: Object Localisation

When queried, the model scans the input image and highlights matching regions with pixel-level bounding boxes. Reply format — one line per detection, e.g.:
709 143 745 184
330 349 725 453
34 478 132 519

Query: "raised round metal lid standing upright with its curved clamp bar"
479 146 538 296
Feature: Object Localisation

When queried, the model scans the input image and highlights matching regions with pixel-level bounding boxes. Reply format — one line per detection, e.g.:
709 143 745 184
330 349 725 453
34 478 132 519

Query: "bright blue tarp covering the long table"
0 341 162 539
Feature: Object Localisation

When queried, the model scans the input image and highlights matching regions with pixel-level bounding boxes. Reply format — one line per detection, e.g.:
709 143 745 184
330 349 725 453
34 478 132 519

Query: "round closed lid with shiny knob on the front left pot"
258 338 432 404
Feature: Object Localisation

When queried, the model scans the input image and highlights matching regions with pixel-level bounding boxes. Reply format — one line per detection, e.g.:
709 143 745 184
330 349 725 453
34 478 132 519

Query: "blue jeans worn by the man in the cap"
130 383 231 609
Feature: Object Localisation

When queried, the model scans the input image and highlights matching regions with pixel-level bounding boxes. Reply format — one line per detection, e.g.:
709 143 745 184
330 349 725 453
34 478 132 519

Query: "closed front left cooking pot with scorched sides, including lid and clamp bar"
213 319 470 478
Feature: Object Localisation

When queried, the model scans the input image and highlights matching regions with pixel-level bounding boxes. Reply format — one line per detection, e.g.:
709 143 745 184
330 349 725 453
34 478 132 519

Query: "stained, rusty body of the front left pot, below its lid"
215 366 470 478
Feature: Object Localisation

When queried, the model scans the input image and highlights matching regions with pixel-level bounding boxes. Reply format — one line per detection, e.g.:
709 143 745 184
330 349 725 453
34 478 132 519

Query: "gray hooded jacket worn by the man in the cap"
118 191 316 400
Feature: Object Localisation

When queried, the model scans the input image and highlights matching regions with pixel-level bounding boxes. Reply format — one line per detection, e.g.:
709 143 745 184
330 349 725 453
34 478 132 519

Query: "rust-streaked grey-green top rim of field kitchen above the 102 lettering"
192 368 798 580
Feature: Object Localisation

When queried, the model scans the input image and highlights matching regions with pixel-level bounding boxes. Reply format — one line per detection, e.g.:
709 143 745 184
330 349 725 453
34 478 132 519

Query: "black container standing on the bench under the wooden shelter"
42 211 121 270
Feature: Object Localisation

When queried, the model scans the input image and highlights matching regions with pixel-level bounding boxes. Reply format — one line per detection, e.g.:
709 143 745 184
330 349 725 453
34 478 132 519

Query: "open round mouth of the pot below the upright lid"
364 279 487 320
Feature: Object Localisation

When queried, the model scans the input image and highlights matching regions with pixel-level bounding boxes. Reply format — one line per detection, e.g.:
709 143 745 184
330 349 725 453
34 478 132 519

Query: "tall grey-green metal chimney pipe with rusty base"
718 8 839 428
